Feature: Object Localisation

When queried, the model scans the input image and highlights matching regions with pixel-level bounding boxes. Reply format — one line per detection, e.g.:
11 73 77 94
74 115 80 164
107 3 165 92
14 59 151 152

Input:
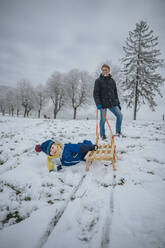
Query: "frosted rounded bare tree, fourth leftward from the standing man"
18 79 35 117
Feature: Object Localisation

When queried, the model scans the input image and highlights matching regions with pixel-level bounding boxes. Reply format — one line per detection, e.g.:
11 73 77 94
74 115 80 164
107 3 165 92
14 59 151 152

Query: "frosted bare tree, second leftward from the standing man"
47 71 65 119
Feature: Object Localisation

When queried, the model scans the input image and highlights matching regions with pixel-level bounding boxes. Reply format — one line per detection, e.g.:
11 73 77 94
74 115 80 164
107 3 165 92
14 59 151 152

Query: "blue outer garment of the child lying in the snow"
61 140 95 166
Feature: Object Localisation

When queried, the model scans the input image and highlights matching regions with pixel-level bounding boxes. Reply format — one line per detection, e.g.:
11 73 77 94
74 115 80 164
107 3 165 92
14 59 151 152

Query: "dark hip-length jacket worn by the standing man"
93 74 120 108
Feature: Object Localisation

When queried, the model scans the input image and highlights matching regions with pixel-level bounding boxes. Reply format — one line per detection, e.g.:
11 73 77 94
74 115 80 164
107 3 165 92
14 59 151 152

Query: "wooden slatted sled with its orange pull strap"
85 109 116 171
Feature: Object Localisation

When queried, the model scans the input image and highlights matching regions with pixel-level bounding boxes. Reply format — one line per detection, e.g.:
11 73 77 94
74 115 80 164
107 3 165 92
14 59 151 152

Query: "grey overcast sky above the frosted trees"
0 0 165 86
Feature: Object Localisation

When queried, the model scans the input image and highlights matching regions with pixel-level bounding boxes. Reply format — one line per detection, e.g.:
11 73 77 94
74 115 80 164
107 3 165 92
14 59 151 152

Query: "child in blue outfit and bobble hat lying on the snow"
35 140 98 172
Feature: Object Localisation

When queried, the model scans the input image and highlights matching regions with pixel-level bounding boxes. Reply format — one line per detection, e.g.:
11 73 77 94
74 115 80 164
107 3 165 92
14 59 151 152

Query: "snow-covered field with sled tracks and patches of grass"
0 117 165 248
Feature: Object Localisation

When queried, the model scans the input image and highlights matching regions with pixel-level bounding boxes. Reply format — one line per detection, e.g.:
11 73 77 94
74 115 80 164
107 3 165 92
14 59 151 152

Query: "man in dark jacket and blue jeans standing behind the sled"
93 64 123 140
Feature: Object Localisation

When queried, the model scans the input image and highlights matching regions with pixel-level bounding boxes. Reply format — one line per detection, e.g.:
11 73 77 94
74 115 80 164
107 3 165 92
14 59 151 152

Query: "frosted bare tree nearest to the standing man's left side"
65 69 91 119
